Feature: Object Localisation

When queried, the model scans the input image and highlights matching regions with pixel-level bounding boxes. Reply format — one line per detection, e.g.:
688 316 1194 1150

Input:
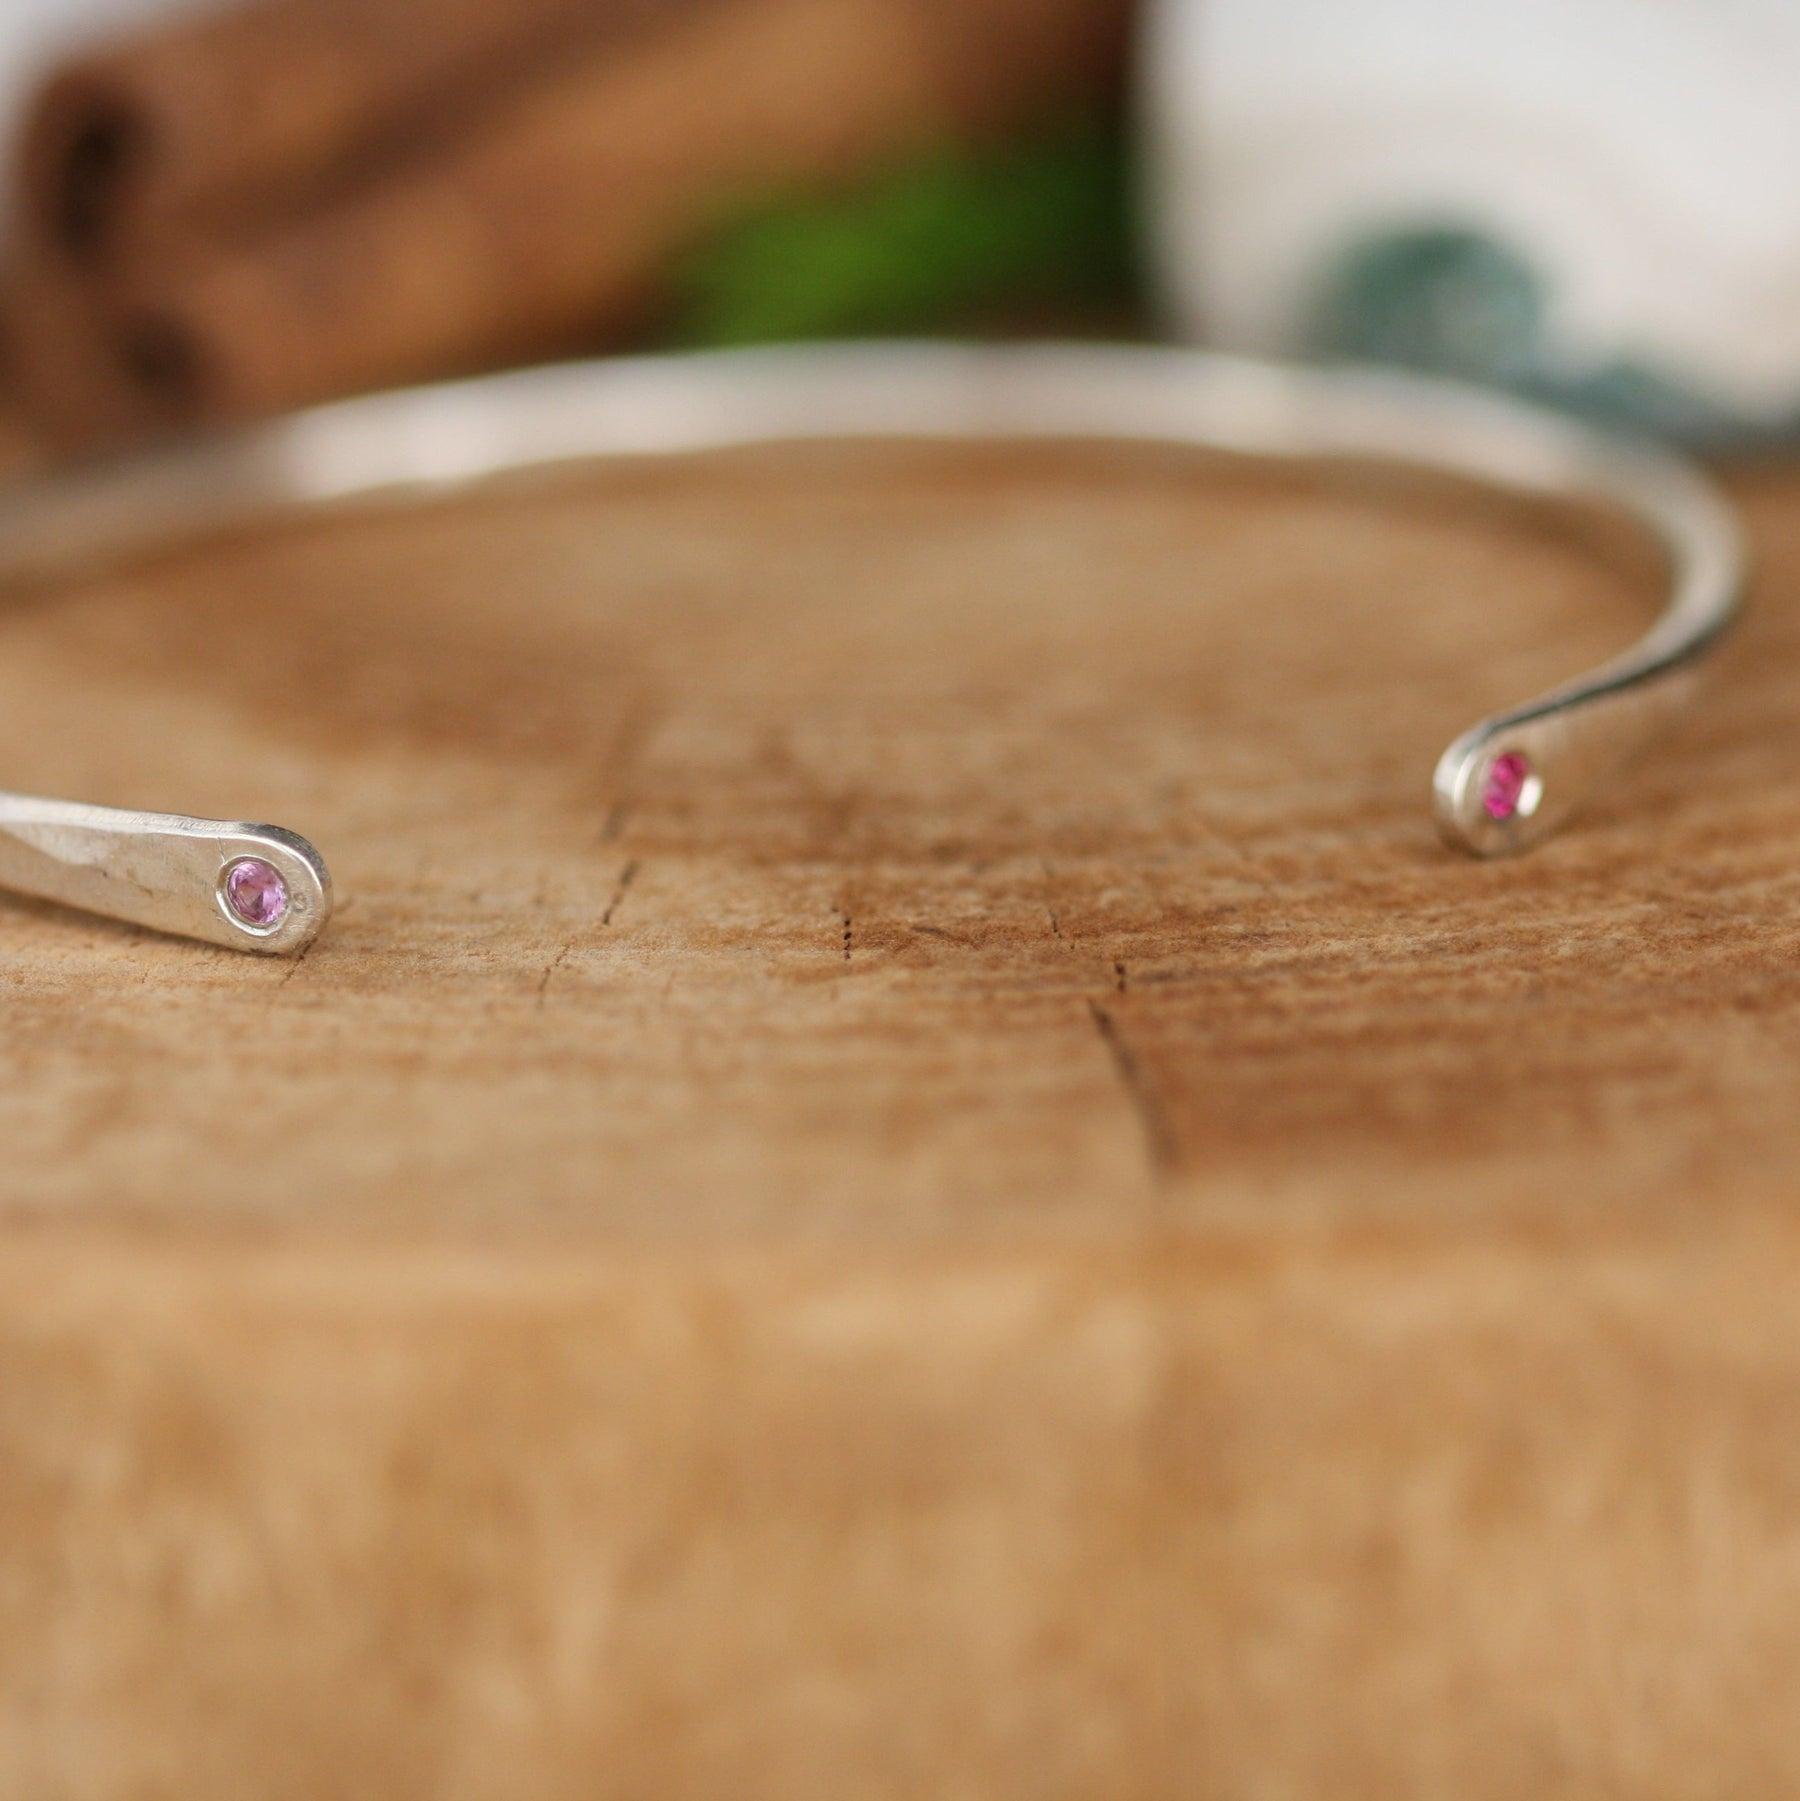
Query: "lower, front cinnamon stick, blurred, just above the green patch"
14 0 1128 436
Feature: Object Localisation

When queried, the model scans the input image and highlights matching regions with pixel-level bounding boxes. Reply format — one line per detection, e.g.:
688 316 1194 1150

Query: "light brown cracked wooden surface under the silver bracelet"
0 435 1800 1801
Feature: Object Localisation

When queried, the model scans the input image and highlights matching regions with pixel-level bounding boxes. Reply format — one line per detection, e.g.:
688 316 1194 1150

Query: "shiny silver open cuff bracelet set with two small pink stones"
0 344 1742 951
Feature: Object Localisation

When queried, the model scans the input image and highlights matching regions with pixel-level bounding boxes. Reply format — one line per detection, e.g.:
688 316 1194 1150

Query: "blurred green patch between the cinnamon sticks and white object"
670 121 1137 344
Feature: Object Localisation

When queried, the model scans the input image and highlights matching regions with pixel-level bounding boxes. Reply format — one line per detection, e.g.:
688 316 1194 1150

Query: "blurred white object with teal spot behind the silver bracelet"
1144 0 1800 429
